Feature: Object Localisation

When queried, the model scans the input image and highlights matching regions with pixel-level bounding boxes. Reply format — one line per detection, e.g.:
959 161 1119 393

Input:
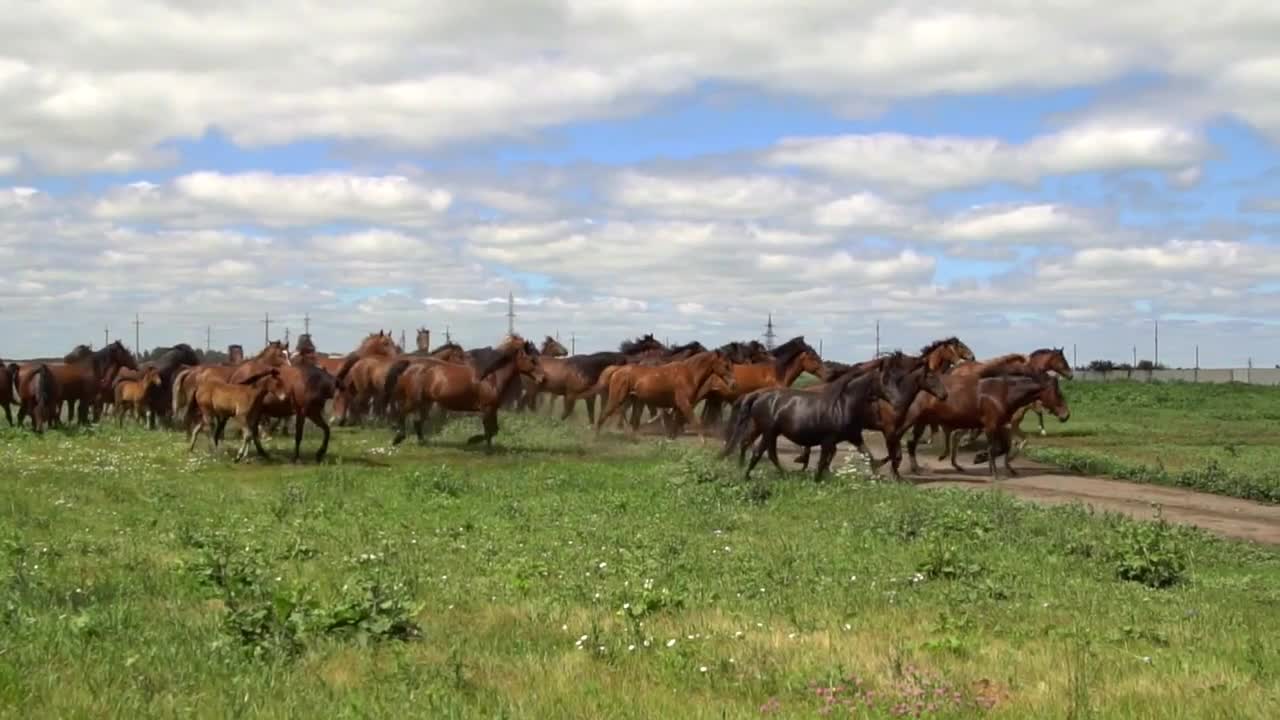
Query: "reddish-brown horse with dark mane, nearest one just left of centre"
384 337 541 450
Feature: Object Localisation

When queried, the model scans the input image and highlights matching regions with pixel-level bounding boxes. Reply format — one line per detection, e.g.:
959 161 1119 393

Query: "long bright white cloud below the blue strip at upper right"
765 123 1207 192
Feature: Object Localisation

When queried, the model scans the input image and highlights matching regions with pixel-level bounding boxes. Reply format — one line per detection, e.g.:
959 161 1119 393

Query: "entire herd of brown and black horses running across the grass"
0 329 1071 478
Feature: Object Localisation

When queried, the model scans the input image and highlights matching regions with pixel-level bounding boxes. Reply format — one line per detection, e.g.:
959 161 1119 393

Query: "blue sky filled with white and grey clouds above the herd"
0 0 1280 366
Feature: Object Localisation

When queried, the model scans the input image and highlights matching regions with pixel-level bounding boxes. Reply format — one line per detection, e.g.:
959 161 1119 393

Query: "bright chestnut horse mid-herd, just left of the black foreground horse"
595 351 735 441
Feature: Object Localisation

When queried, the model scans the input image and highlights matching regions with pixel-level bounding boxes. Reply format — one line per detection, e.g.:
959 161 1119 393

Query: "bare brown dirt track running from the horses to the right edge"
665 420 1280 544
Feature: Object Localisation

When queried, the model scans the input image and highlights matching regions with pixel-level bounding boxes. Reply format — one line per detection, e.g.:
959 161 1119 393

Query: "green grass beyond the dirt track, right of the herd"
1023 380 1280 502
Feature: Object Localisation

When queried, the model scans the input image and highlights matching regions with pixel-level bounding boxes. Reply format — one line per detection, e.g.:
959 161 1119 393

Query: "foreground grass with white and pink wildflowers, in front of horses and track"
0 404 1280 719
